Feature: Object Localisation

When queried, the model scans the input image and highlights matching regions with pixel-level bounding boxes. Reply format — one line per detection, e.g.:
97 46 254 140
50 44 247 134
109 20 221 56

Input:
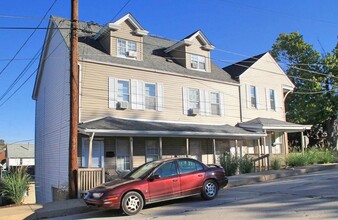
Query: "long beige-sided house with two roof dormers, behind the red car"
33 14 308 203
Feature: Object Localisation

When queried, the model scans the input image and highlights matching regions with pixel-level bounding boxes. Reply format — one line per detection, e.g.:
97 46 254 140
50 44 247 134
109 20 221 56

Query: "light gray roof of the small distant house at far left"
7 144 34 158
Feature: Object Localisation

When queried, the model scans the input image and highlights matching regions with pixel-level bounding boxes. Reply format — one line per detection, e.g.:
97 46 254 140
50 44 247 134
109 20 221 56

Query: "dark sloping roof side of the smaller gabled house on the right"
223 53 266 81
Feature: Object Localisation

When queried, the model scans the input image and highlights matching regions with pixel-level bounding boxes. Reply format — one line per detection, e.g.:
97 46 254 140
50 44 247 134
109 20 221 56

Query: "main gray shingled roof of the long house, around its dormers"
51 16 237 84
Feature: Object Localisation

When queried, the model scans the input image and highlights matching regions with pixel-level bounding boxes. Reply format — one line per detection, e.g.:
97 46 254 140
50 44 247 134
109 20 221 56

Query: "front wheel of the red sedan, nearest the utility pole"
121 191 144 215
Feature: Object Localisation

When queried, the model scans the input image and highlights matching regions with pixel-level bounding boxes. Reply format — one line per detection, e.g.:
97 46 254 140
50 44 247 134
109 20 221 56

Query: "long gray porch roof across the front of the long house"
79 117 265 139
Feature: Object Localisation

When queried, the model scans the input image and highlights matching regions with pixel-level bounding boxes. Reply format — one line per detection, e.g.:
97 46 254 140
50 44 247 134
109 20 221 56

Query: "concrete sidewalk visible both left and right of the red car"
0 164 338 220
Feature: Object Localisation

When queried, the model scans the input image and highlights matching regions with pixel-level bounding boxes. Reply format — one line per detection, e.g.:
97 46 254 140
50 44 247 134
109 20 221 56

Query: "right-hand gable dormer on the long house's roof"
164 30 215 72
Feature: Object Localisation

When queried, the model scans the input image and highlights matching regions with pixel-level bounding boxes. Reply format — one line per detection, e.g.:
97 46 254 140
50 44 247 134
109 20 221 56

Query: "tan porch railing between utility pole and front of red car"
77 168 105 198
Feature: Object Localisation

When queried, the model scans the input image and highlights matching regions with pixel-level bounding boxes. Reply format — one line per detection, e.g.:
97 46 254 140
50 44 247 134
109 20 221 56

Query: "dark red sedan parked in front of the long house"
84 158 228 215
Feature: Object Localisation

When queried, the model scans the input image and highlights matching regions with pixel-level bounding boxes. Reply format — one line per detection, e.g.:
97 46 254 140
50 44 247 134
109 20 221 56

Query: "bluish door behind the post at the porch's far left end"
82 138 104 168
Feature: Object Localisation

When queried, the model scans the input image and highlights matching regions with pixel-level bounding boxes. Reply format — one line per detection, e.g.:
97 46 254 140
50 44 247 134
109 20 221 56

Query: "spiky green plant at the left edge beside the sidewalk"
0 167 31 205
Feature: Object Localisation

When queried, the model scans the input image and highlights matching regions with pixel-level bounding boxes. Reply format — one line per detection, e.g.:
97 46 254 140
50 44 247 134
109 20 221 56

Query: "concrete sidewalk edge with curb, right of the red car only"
226 164 338 188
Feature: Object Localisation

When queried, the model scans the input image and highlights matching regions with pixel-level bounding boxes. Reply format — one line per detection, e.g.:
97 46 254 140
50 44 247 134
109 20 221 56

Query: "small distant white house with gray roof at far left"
6 144 35 169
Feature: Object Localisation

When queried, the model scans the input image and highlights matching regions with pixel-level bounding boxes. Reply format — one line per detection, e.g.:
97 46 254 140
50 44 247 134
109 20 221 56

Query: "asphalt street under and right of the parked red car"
50 169 338 220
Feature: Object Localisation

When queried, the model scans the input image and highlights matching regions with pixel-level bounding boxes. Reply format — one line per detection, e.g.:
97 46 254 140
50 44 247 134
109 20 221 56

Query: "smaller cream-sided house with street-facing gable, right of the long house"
223 52 311 155
